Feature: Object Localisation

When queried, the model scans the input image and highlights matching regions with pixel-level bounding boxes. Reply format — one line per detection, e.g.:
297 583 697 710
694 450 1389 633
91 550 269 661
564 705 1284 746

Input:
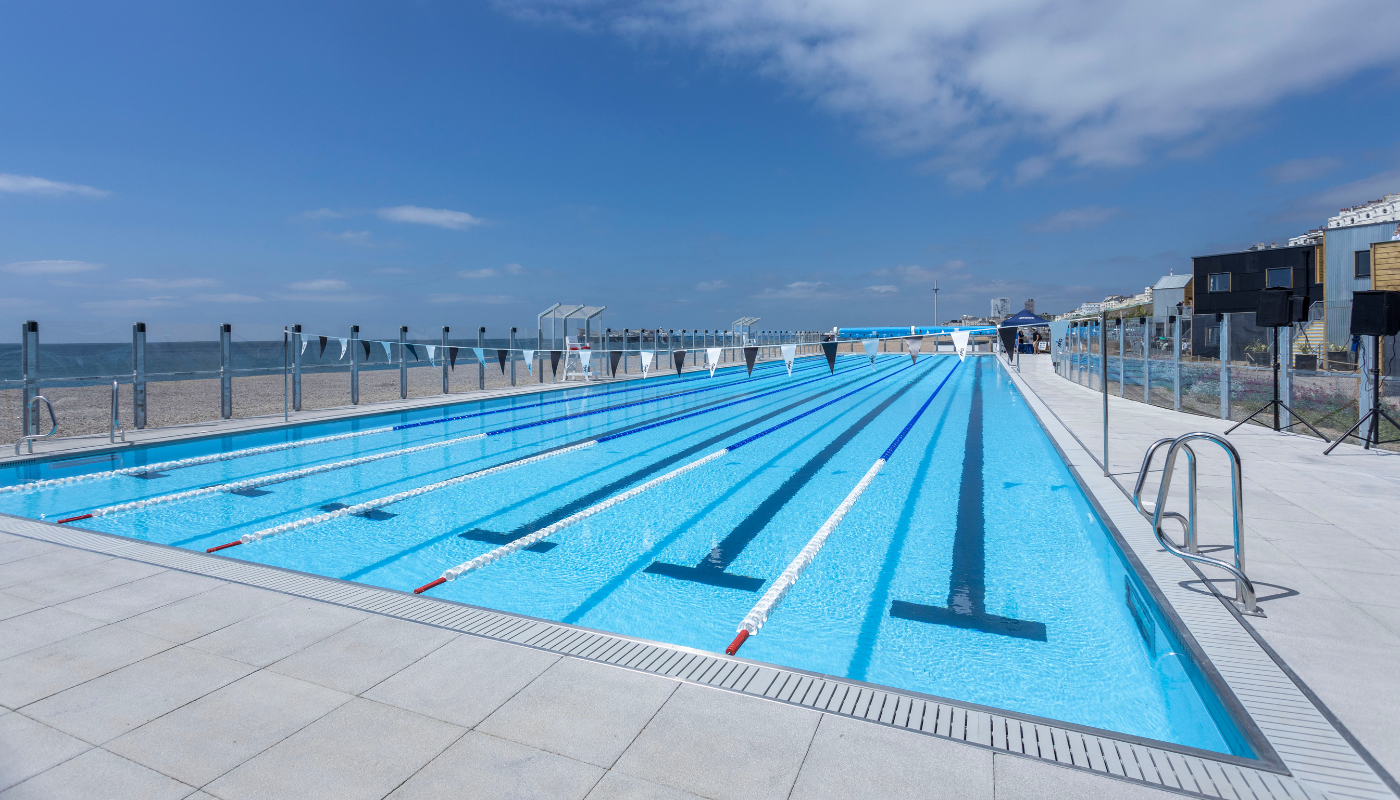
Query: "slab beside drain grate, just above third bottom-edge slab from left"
477 658 679 768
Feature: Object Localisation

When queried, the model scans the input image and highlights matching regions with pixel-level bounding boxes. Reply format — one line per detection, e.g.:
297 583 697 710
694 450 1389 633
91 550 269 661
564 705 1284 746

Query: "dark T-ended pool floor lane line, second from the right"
645 358 937 591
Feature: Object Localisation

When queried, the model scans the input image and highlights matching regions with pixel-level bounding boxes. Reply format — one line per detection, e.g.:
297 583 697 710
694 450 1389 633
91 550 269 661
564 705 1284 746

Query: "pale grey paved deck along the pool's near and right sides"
0 353 1400 800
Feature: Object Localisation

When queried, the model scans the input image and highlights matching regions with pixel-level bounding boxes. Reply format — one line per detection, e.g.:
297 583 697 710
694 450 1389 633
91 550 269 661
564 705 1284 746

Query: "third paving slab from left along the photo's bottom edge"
389 731 603 800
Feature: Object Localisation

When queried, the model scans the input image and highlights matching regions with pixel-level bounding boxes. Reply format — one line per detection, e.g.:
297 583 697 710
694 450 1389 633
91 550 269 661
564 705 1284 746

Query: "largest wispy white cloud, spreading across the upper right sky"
514 0 1400 172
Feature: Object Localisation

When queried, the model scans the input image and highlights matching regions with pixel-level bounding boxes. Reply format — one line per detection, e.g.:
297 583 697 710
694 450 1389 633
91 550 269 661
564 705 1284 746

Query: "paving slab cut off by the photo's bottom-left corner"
0 748 195 800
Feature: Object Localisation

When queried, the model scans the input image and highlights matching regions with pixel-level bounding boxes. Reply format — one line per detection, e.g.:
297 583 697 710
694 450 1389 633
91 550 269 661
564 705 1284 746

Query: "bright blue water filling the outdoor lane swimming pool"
0 354 1252 757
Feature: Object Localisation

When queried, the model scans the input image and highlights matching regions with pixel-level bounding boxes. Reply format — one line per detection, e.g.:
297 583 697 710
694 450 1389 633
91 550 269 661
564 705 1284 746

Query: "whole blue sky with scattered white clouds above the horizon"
0 0 1400 340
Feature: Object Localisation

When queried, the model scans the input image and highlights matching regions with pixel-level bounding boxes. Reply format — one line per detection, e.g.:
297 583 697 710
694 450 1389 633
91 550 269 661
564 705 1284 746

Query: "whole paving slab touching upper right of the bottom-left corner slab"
106 671 353 786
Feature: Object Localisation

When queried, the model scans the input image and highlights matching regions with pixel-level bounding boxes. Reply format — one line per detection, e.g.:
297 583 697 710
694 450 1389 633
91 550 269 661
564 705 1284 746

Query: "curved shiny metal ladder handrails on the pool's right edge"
1133 432 1264 616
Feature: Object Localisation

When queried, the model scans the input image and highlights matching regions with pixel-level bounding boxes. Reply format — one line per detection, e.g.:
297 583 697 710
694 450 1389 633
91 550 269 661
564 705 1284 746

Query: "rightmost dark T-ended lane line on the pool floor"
889 360 1046 642
